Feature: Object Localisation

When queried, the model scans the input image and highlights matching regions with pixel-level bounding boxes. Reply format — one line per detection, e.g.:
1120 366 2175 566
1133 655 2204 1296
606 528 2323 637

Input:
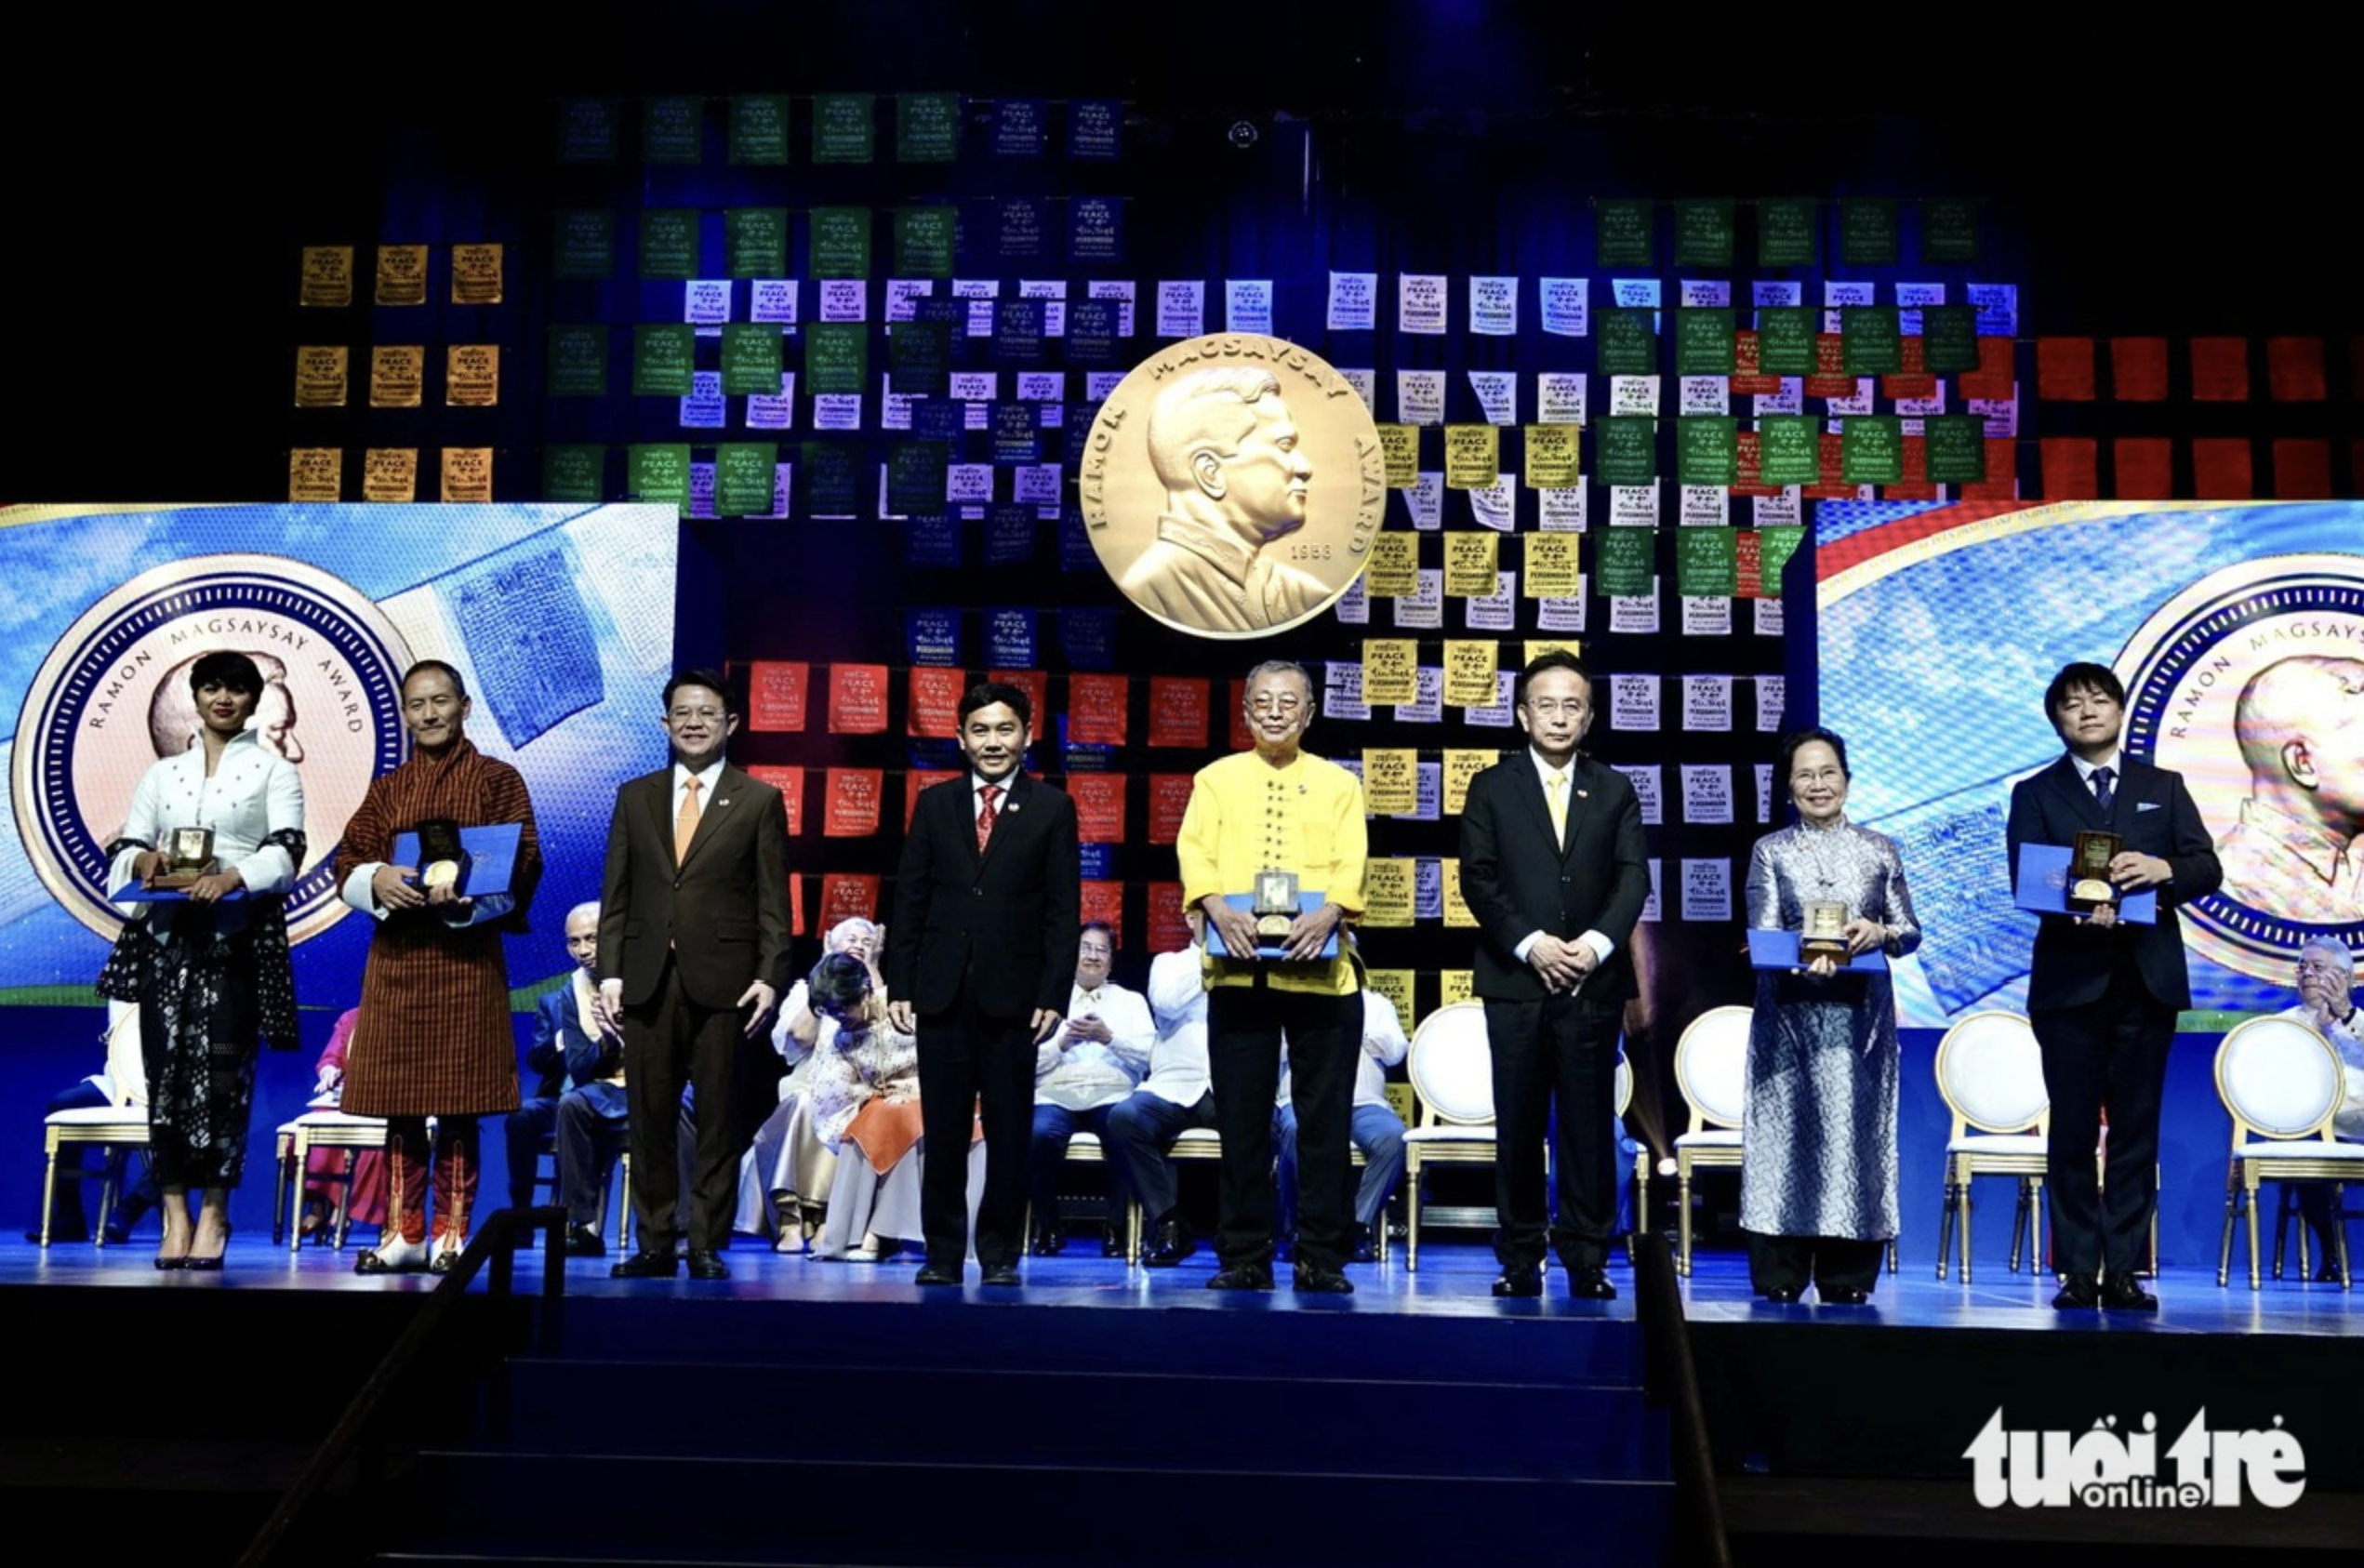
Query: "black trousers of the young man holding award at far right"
2028 953 2175 1280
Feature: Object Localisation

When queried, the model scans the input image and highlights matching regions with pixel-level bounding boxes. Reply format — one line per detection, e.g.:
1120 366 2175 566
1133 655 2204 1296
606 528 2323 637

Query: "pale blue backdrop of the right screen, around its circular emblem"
1815 501 2364 1029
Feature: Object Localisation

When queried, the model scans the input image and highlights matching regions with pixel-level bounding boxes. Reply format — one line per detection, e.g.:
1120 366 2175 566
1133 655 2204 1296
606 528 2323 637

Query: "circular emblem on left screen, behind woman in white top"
9 556 411 941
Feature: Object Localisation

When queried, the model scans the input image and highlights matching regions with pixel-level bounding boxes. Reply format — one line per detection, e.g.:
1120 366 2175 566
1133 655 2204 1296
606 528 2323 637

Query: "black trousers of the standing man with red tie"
920 991 1033 1270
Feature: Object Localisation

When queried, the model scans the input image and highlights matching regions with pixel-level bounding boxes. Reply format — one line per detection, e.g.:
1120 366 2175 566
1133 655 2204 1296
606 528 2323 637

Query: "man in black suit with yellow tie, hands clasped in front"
1461 650 1650 1301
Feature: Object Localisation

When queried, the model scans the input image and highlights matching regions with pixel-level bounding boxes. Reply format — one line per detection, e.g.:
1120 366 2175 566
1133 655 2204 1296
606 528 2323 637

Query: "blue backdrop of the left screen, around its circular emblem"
0 504 679 1010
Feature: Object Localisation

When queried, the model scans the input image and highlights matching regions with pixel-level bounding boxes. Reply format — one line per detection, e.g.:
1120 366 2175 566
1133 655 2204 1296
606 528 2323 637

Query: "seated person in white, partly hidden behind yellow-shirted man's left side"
1099 909 1215 1268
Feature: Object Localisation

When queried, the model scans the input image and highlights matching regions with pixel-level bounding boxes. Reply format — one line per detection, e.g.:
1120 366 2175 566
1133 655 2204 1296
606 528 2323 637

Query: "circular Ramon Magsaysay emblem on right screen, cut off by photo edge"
2118 553 2364 981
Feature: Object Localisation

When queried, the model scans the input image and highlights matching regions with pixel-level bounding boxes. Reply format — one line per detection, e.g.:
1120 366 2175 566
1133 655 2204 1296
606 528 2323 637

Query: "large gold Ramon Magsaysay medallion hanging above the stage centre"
1078 334 1388 636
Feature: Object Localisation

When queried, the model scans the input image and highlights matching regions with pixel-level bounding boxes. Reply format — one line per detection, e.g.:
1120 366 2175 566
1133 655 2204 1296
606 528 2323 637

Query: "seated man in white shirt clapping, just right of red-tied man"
1026 920 1159 1258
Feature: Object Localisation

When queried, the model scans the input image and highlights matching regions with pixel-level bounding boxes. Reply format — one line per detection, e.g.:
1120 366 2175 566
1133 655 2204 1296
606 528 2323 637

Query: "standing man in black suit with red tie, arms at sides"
886 681 1082 1284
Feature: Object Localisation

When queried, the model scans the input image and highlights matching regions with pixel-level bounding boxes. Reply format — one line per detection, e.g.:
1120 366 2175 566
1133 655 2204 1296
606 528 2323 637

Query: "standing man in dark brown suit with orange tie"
598 670 787 1280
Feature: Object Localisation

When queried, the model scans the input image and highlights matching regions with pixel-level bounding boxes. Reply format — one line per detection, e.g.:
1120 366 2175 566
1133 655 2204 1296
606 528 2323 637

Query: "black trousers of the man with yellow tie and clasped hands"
1484 991 1624 1272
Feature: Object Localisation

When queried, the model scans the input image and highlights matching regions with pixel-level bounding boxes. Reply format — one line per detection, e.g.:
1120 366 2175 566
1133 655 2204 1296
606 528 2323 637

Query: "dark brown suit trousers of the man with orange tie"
624 955 742 1254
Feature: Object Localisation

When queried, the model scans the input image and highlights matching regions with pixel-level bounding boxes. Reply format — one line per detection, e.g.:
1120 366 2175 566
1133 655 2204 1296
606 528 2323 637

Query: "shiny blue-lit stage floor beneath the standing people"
0 1237 2364 1336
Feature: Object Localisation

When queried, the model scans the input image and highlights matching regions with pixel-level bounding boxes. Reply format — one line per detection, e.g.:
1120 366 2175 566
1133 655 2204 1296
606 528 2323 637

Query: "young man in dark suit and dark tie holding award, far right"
2005 665 2225 1312
